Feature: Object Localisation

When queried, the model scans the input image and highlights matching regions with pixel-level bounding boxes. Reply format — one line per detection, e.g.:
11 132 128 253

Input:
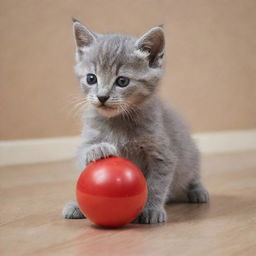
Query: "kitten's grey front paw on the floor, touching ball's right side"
133 207 167 224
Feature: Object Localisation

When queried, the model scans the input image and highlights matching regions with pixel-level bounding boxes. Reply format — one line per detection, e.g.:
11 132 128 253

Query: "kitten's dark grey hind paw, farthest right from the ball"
187 180 210 204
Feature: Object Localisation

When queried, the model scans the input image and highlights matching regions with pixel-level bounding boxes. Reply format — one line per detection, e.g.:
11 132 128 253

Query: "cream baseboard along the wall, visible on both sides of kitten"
0 129 256 166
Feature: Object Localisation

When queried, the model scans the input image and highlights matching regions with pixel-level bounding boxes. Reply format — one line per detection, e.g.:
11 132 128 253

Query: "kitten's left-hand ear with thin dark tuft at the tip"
72 18 97 55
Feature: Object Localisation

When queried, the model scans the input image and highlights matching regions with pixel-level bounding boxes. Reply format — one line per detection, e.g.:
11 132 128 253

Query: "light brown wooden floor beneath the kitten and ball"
0 152 256 256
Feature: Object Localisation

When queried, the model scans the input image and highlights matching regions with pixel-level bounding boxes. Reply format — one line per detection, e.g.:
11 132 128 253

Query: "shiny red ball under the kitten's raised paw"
76 157 147 227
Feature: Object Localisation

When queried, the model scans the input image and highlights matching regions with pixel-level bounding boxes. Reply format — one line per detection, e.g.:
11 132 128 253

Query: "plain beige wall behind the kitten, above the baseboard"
0 0 256 140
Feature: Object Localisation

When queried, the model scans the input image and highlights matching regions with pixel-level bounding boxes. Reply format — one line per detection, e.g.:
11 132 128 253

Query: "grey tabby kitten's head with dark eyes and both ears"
74 20 164 117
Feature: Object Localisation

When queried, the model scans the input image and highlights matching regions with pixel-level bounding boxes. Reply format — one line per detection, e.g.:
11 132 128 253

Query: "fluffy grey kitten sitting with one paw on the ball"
63 20 209 223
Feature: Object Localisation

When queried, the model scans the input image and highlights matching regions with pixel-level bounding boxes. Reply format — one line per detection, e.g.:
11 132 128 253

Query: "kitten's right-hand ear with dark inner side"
136 25 165 67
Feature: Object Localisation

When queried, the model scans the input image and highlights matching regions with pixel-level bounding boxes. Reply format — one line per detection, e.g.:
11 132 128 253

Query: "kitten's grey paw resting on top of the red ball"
86 142 118 164
